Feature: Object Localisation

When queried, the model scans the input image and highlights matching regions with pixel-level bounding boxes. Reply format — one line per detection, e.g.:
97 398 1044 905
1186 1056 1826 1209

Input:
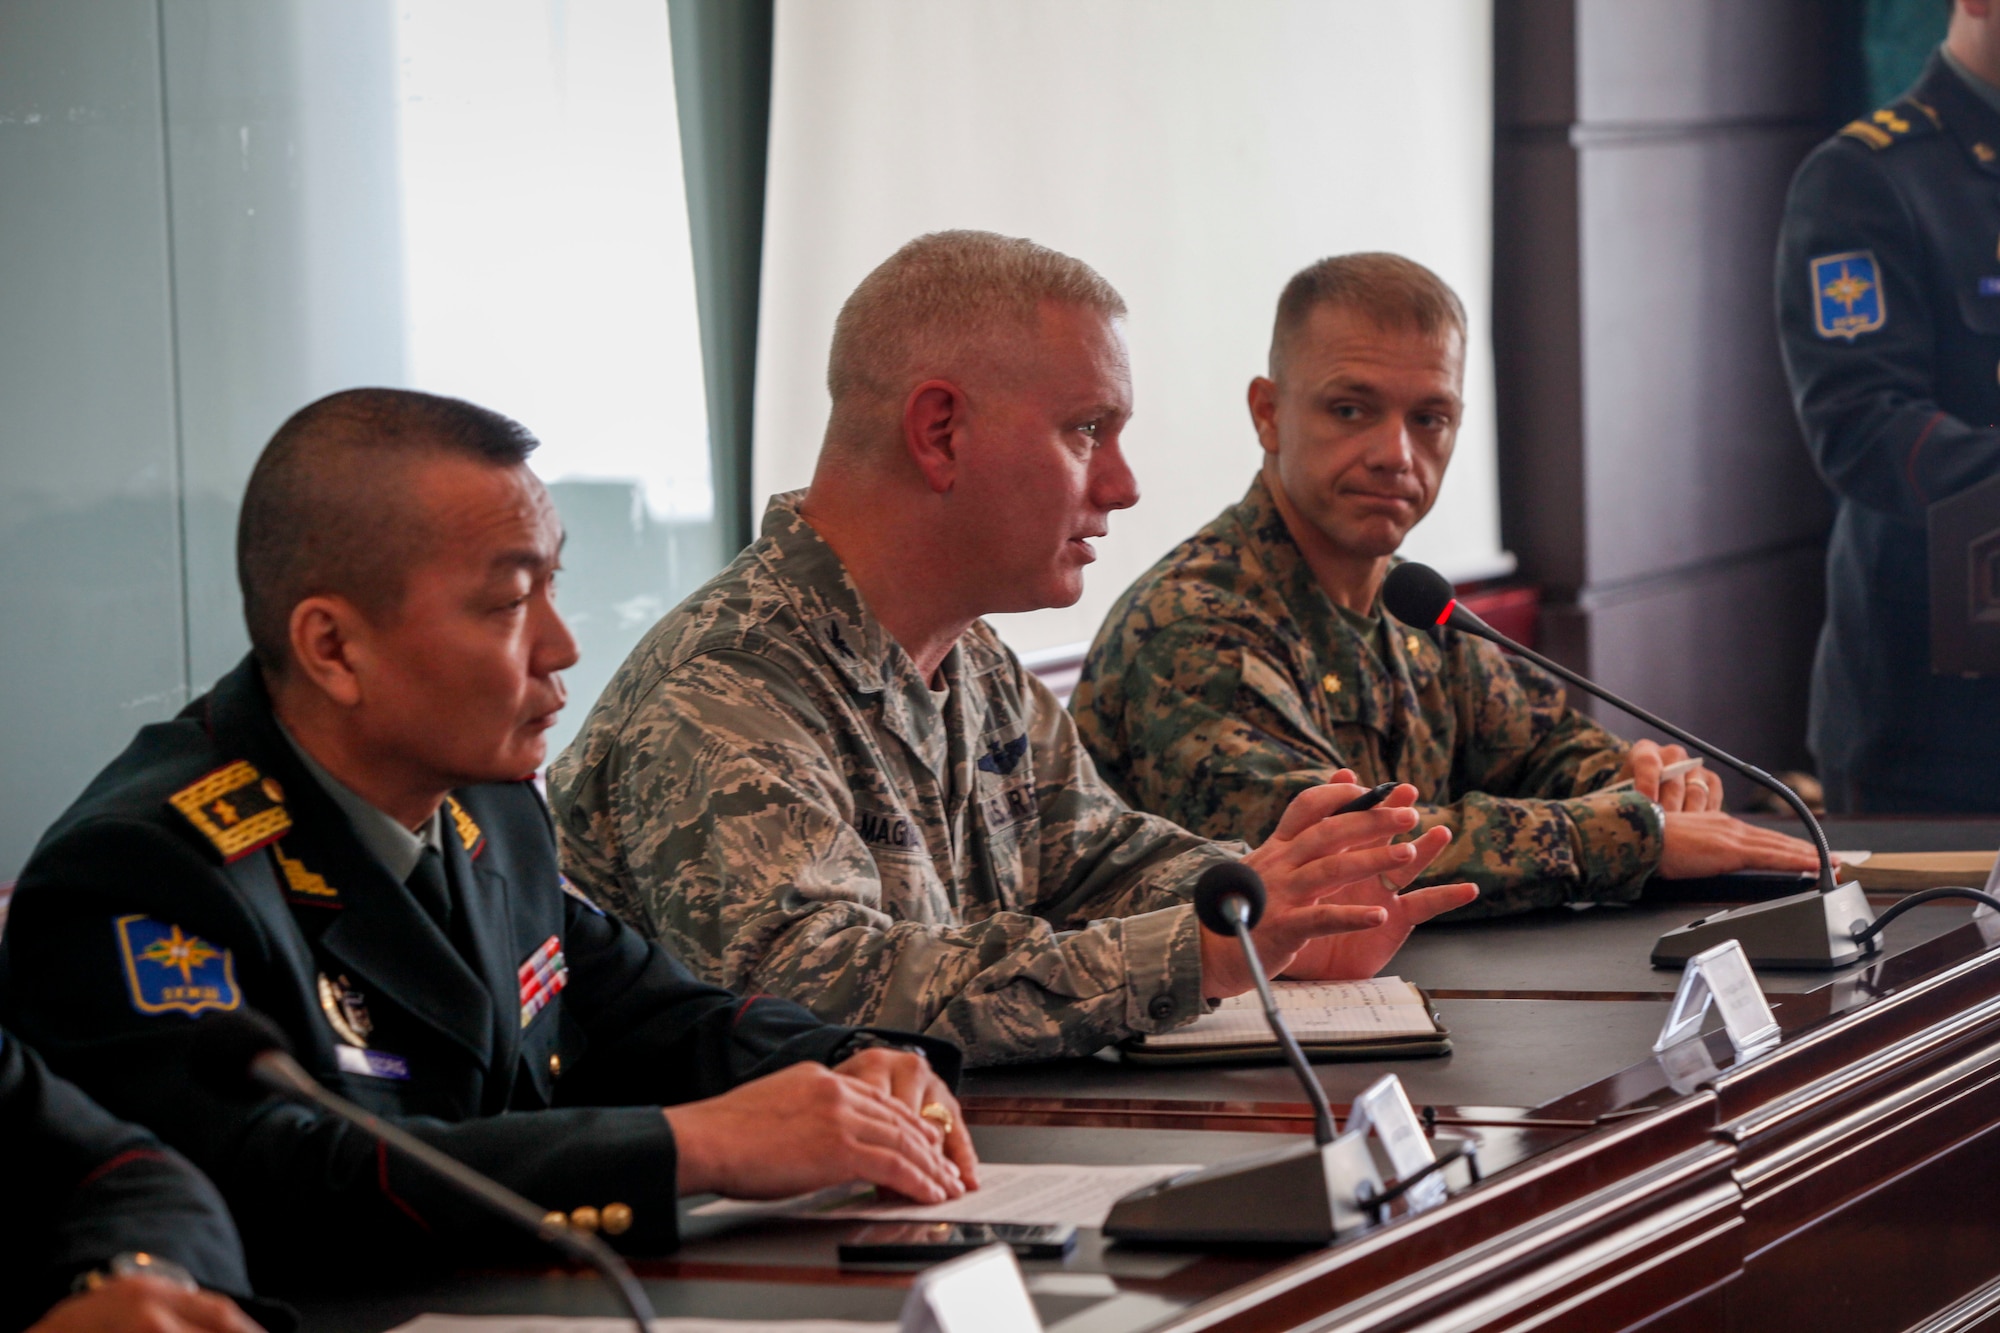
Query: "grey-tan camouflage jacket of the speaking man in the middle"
550 494 1240 1065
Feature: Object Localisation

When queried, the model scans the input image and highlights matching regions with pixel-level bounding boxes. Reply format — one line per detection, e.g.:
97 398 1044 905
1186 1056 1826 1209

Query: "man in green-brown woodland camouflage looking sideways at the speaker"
1070 254 1818 915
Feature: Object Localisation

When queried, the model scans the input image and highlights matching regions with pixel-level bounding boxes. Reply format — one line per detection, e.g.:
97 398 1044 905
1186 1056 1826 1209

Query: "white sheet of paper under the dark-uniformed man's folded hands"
694 1161 1194 1227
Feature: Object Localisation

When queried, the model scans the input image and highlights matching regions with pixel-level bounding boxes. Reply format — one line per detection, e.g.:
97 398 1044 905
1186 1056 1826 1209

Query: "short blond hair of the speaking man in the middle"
826 230 1126 438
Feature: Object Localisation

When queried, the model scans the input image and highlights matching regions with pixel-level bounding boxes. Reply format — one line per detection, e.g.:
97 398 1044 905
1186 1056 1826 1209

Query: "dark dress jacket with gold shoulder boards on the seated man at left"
0 660 958 1285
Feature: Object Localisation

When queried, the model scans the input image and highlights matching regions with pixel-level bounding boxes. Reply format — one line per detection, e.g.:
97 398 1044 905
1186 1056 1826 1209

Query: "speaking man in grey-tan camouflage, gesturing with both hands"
550 232 1474 1063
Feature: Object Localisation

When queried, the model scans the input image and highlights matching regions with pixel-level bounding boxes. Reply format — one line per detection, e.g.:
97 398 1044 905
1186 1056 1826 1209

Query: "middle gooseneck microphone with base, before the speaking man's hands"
1104 861 1384 1245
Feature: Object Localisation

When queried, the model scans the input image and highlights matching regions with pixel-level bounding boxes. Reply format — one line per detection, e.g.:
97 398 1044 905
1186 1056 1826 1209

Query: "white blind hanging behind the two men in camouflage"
754 0 1512 652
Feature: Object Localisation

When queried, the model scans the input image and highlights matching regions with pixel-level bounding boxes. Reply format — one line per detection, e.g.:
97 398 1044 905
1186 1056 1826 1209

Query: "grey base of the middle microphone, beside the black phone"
1104 1131 1382 1245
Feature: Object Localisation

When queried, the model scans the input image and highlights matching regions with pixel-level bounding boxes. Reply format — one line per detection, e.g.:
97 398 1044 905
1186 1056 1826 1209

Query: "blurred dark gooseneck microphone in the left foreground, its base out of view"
190 1009 654 1333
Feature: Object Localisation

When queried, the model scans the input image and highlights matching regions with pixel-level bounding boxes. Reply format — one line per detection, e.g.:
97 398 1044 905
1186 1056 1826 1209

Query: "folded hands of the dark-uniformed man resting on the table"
666 1057 966 1203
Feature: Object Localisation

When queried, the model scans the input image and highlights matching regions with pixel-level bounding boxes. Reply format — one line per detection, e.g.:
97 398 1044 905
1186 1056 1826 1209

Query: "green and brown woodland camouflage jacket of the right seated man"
1070 476 1662 919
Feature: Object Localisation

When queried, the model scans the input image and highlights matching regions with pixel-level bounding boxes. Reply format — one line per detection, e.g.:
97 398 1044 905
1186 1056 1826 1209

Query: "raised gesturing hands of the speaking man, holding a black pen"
1202 771 1478 999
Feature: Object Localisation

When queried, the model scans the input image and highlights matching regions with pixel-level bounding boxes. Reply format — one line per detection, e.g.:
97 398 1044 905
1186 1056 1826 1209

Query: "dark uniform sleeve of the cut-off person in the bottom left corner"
0 1031 250 1331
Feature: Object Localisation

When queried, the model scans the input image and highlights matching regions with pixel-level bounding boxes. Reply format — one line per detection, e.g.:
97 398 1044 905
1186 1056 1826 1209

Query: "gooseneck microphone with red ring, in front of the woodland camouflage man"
1382 560 1886 967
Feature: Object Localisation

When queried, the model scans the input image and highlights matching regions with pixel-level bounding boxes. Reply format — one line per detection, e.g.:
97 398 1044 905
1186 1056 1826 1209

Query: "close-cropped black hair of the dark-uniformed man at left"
236 388 538 675
